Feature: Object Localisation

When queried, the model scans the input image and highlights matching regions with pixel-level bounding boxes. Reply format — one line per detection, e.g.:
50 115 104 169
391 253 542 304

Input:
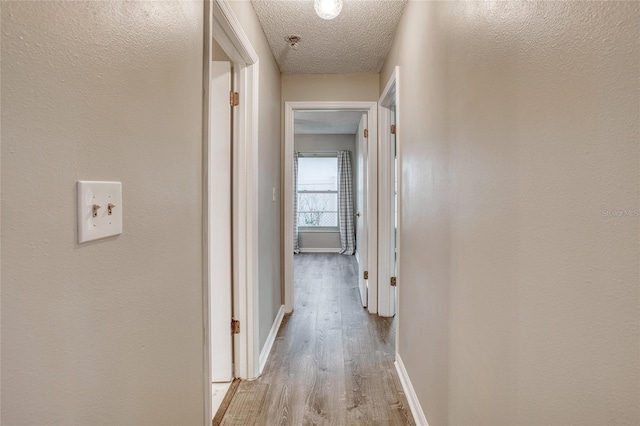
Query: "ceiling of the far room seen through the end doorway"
294 111 363 135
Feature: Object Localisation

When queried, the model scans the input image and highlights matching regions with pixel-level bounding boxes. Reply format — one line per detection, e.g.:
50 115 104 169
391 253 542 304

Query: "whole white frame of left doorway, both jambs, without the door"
202 0 259 425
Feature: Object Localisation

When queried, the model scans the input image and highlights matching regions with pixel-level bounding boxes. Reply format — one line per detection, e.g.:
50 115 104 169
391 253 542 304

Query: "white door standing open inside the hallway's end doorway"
356 114 369 307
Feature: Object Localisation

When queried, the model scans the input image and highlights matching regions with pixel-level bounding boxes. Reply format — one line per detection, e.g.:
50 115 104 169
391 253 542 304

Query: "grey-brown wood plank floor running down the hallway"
221 254 415 426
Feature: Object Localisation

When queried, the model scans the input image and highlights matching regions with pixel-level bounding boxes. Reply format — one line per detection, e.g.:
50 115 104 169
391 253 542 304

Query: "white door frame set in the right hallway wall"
378 66 402 318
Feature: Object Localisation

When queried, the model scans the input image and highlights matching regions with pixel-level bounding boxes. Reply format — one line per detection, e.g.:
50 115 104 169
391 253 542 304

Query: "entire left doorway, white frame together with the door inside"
208 0 259 420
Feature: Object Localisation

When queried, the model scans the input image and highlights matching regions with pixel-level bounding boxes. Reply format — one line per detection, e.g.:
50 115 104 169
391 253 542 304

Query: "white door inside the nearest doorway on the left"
208 62 233 382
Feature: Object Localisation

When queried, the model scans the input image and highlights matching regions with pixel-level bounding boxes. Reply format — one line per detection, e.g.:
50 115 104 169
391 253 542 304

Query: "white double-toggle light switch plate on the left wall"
78 181 122 243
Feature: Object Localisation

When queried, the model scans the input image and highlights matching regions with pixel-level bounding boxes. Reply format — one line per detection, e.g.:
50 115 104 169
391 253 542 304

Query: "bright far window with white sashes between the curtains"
298 153 338 229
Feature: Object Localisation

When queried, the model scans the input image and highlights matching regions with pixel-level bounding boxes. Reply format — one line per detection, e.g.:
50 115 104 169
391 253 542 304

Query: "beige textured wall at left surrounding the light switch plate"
0 1 205 425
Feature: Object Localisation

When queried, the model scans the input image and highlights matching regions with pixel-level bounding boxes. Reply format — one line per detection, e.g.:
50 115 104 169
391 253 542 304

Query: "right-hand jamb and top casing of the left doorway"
212 0 260 379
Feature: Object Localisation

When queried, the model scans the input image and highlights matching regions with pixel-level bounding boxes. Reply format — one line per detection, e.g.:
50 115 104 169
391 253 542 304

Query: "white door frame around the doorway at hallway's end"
282 102 378 313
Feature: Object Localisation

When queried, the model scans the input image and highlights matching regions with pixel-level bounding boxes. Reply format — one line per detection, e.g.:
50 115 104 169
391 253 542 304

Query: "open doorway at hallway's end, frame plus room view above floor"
284 102 377 313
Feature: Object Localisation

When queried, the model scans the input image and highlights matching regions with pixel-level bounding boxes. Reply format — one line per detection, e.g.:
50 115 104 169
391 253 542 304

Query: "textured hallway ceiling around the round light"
251 0 406 74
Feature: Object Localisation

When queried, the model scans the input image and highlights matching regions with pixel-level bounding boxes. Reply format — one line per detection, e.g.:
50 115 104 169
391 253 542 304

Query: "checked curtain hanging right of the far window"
338 151 356 255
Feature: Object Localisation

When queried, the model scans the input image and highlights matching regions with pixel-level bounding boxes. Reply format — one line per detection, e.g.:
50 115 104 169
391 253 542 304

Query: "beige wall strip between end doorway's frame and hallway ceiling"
282 74 379 103
